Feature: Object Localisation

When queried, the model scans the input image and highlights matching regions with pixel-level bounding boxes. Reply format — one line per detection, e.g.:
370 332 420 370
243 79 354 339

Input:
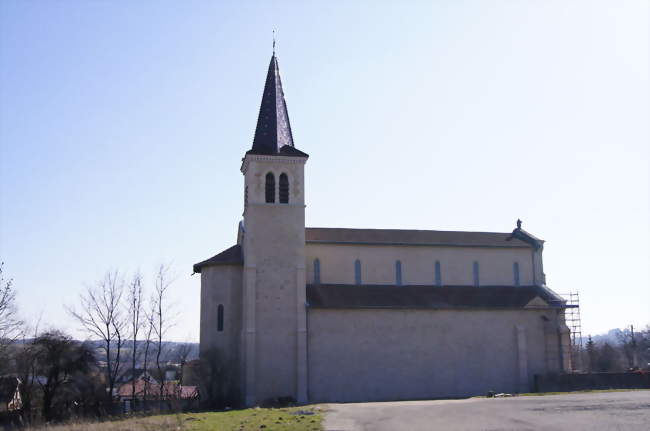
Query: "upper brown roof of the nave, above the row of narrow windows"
305 227 539 248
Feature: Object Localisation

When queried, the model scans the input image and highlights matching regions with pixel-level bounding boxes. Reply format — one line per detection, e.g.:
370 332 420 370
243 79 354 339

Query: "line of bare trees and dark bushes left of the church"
0 265 191 424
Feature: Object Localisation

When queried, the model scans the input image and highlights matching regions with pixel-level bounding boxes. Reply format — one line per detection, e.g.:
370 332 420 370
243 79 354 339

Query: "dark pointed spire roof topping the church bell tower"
249 54 293 154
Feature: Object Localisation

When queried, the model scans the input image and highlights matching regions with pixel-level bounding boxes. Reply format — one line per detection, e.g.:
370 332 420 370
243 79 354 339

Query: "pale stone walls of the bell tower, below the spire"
242 155 306 406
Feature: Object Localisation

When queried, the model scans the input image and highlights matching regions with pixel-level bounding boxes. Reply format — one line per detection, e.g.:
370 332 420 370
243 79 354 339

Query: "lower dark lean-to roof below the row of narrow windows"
307 284 570 309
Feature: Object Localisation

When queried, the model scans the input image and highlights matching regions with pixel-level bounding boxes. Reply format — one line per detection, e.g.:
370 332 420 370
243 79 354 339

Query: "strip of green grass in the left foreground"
35 406 323 431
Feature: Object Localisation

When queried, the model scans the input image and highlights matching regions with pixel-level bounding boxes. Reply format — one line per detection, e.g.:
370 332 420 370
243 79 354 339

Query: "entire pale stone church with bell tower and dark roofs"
194 52 571 406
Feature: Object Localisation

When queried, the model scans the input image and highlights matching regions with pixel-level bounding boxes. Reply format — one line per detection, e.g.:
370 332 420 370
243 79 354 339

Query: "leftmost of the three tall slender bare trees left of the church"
68 271 127 401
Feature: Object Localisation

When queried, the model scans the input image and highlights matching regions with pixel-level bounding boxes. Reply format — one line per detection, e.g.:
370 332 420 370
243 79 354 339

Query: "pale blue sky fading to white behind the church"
0 0 650 340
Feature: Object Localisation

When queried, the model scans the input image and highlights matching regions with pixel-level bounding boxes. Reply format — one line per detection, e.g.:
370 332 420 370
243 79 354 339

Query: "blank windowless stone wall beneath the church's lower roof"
308 308 561 402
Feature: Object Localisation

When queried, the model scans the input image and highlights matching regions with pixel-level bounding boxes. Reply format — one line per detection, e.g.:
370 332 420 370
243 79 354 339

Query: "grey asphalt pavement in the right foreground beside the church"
325 390 650 431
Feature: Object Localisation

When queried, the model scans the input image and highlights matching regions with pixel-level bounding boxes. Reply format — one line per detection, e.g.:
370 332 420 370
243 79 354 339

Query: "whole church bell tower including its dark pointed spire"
241 52 309 406
